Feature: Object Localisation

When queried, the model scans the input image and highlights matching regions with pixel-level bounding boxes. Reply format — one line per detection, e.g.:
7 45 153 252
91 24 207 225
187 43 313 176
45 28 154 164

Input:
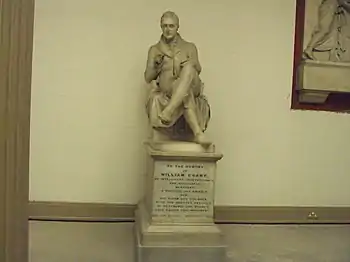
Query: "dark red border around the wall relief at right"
291 0 350 112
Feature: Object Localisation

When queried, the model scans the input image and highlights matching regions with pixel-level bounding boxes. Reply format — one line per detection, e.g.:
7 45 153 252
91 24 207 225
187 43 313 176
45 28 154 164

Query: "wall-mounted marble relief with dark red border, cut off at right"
292 0 350 111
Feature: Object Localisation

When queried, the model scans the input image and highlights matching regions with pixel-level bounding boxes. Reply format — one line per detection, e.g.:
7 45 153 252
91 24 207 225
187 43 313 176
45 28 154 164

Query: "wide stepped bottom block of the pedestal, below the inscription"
134 207 227 262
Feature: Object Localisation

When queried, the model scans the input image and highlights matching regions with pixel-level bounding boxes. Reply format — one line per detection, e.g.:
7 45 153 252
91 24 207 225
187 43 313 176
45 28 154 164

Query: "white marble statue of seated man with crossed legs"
144 11 210 145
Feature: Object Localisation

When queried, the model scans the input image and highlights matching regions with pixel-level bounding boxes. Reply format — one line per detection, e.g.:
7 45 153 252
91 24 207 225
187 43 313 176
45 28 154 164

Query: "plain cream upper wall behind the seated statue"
30 0 350 206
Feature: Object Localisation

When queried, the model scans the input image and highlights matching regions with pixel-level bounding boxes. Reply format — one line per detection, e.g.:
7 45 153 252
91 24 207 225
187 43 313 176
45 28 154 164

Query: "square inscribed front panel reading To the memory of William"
152 161 215 223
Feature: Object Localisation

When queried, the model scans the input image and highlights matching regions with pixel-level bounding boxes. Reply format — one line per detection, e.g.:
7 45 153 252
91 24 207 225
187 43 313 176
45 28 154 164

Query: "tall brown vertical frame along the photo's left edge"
0 0 34 262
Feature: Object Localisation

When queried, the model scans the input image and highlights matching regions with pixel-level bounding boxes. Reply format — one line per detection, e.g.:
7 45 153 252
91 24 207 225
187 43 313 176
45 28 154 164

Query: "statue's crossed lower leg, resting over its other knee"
159 64 198 123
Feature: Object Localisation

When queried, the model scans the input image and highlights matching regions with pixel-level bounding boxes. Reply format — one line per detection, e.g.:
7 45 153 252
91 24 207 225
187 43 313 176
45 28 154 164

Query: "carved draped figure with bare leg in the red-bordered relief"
303 0 350 62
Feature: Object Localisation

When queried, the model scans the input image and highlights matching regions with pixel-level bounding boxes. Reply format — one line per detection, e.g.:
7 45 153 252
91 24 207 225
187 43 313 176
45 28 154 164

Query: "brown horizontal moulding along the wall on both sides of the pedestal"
29 201 350 224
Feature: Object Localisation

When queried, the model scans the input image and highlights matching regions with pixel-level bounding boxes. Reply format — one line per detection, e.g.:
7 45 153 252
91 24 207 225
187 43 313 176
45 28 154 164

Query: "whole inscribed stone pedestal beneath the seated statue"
135 142 226 262
